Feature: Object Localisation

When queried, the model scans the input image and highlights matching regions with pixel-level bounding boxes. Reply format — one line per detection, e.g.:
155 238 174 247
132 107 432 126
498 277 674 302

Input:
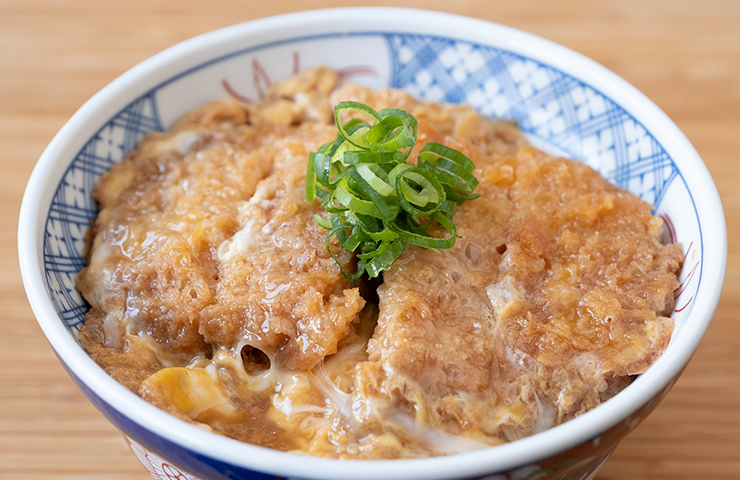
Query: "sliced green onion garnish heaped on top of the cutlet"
306 102 478 280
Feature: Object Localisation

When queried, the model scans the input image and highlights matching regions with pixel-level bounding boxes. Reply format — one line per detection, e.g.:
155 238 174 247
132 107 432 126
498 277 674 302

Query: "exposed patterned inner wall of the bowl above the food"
43 27 703 338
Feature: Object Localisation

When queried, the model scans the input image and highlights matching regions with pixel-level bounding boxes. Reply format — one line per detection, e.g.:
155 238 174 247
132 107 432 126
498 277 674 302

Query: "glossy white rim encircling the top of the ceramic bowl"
18 7 727 480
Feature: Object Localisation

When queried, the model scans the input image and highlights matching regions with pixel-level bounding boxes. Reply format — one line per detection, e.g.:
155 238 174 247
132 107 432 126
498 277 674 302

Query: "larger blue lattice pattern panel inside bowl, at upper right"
388 35 678 206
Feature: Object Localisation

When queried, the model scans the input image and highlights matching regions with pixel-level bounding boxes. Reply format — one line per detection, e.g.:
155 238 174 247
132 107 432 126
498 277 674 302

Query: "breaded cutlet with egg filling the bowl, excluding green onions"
78 68 683 458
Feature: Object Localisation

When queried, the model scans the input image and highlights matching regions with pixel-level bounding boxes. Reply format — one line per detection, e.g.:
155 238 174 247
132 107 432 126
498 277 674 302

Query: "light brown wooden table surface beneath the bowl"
0 0 740 480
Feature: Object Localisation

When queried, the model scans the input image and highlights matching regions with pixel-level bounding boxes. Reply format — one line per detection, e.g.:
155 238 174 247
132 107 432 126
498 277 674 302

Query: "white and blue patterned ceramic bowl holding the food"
18 8 727 480
